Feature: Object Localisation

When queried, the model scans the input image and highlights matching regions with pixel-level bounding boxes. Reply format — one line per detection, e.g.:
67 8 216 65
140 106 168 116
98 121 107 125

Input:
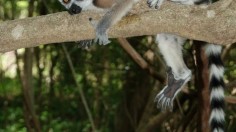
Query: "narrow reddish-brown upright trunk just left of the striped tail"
194 41 210 132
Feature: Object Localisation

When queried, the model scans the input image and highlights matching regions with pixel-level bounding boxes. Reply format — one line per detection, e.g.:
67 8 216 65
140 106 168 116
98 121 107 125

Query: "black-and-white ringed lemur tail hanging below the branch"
205 44 225 132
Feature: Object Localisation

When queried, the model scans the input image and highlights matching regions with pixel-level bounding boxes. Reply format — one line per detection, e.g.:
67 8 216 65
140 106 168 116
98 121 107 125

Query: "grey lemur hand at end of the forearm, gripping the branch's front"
89 18 111 45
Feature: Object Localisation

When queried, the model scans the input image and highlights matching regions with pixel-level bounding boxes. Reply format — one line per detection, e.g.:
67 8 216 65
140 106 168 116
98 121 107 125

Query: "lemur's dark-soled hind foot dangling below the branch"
155 68 191 111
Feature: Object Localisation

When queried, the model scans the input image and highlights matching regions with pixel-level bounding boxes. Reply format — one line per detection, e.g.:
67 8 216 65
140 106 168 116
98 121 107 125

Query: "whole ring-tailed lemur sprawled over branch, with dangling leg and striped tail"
59 0 224 132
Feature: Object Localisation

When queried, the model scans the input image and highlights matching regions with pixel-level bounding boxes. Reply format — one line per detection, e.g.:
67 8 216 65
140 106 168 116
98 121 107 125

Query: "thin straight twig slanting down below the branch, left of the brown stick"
62 44 97 132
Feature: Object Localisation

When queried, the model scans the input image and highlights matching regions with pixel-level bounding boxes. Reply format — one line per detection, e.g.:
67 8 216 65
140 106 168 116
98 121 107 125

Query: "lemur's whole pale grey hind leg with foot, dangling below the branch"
155 34 191 110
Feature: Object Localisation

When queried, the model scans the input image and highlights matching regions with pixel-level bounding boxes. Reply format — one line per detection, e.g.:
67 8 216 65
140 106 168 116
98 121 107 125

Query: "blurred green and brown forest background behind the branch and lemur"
0 0 236 132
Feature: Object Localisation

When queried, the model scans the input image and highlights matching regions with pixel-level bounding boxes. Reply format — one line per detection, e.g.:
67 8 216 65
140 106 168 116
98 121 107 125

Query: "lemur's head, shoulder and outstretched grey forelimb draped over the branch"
59 0 138 46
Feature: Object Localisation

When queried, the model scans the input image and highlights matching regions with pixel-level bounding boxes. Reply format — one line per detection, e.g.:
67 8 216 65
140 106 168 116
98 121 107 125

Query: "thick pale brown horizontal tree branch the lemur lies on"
0 0 236 52
